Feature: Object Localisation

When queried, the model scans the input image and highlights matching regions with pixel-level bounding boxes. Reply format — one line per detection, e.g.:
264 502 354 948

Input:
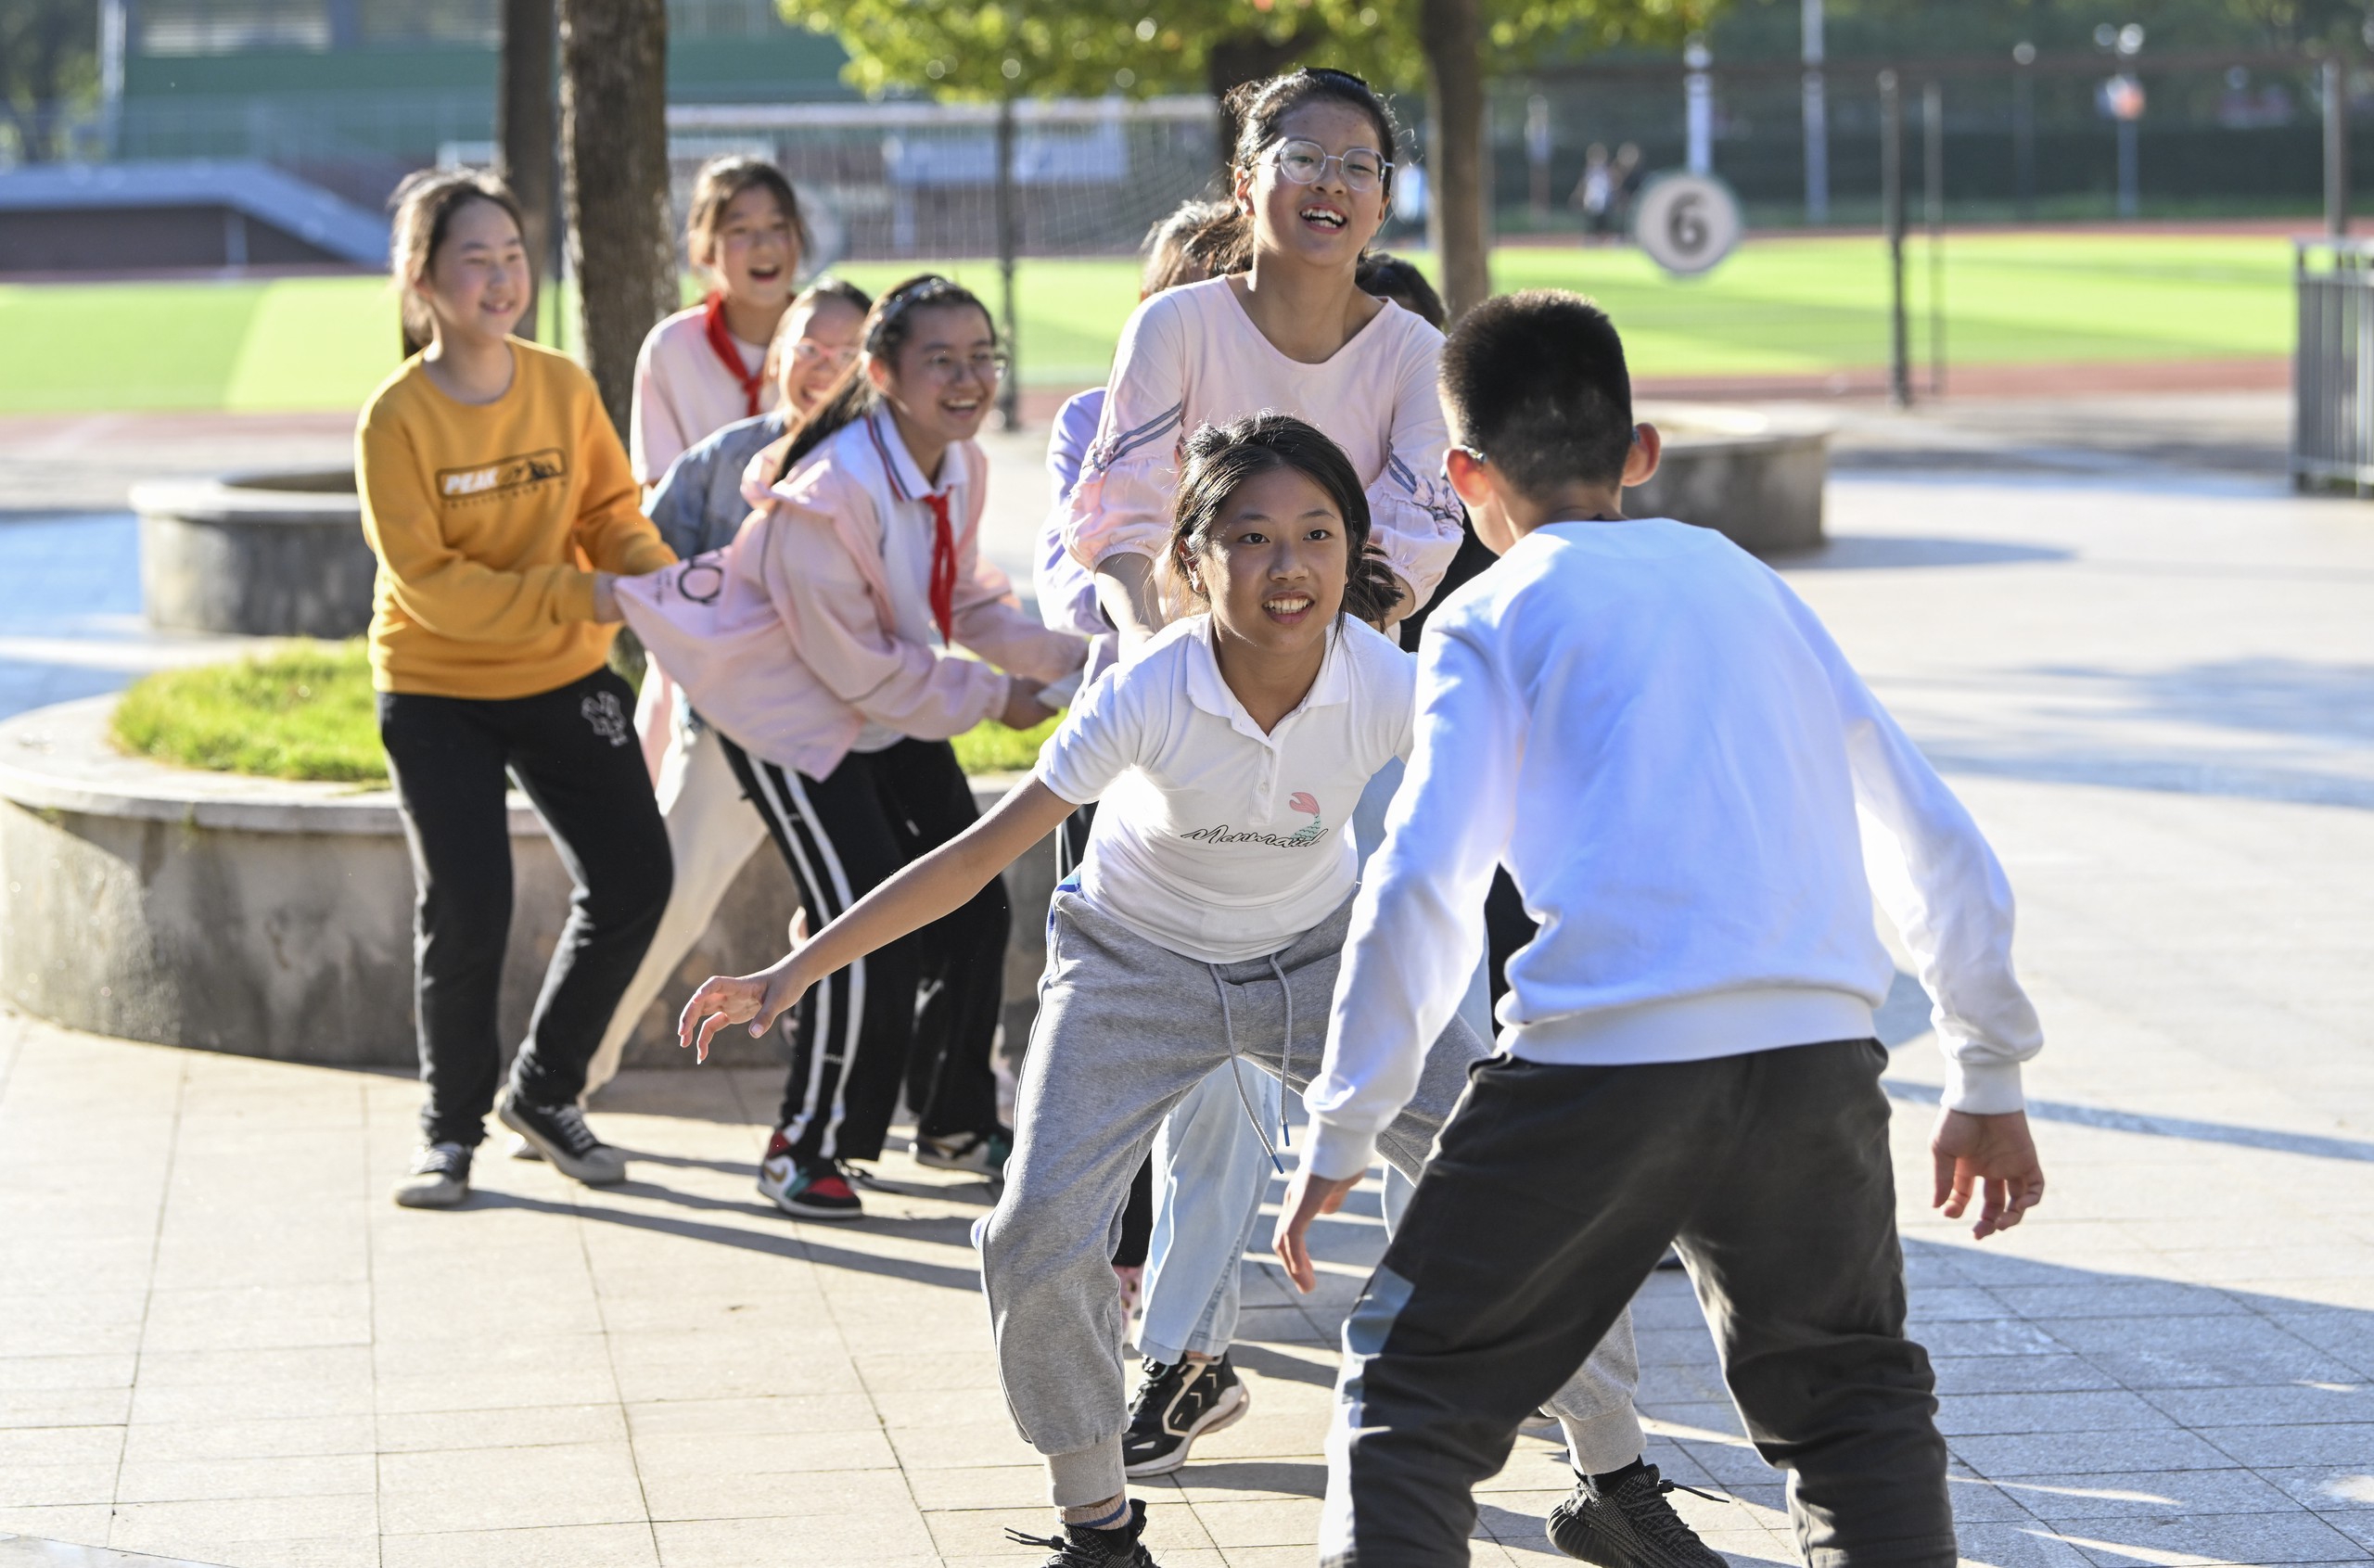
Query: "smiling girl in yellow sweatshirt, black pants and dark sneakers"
356 173 674 1207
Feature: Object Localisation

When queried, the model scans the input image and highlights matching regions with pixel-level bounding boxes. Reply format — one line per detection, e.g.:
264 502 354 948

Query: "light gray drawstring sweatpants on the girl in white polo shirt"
980 887 1640 1509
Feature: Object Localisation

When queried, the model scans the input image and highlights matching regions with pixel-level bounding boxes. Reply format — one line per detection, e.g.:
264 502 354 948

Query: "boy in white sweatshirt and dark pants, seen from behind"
1277 292 2044 1568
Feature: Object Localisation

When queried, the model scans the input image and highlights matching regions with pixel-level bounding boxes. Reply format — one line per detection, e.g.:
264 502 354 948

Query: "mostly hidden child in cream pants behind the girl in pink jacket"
586 277 874 1093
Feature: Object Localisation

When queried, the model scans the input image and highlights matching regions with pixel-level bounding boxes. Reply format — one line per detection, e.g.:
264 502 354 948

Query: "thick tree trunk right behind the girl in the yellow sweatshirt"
560 0 682 432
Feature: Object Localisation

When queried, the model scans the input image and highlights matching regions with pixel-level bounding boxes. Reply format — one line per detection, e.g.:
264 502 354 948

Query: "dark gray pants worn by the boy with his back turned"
1320 1039 1956 1568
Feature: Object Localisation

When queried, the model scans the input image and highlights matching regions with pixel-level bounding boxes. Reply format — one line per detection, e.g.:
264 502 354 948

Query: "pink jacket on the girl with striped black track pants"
618 413 1087 778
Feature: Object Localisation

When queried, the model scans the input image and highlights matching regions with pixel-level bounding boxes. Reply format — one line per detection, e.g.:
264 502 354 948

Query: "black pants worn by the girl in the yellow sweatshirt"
380 669 674 1148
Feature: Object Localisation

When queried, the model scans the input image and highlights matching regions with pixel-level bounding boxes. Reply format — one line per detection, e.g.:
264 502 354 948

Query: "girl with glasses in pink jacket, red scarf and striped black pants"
619 275 1085 1219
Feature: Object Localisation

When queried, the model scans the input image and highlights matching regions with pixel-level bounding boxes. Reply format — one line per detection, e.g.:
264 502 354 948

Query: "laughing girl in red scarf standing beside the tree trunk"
627 157 807 486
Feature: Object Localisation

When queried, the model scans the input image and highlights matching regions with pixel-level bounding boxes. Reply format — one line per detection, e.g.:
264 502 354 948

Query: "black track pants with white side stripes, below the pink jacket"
720 735 1012 1160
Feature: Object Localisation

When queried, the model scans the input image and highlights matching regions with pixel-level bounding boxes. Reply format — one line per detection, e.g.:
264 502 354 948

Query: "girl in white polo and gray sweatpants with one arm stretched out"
679 413 1638 1568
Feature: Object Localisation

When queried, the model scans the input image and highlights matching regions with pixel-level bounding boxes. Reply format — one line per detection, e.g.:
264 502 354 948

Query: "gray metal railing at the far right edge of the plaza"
2291 237 2374 496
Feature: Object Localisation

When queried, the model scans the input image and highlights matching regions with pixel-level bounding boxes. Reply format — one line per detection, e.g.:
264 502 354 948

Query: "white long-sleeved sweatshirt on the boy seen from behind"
1303 519 2042 1177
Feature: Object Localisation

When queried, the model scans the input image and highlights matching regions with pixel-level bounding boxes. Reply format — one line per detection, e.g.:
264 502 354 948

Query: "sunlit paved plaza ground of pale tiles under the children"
0 396 2374 1568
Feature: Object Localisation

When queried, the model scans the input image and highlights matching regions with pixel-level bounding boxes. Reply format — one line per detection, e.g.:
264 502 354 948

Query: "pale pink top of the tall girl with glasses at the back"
1064 277 1460 609
